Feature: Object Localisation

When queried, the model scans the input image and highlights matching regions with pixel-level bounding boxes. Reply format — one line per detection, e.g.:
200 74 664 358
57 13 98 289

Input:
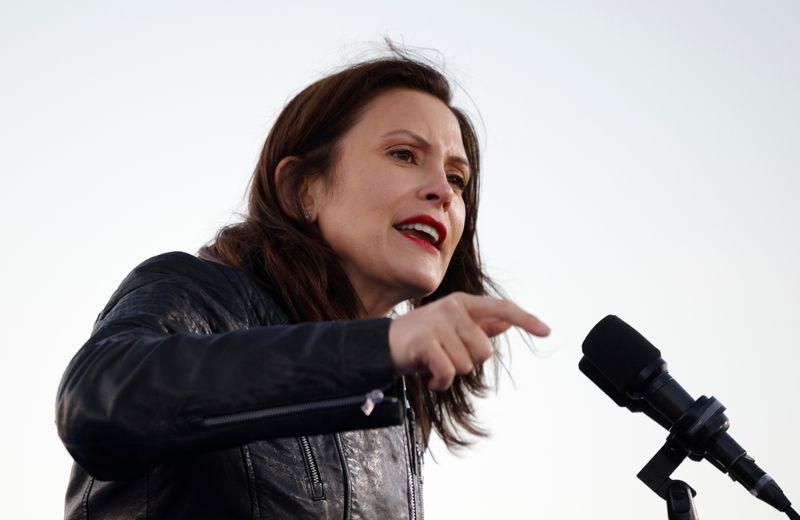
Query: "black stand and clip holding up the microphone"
636 396 730 520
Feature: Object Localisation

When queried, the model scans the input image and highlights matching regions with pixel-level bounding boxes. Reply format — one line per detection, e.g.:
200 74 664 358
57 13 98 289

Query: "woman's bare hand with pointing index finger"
389 293 550 391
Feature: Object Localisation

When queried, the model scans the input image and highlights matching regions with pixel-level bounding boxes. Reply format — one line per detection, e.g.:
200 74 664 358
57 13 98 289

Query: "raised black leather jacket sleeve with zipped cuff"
56 253 404 480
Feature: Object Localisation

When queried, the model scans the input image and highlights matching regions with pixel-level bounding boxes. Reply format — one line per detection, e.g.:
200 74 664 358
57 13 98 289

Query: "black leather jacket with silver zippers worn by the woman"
56 253 422 520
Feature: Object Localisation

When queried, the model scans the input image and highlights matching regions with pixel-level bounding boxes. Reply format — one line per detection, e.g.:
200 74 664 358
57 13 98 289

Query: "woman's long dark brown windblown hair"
201 53 492 448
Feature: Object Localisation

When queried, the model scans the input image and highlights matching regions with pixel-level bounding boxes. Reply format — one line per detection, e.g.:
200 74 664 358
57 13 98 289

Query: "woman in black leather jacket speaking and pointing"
57 57 548 519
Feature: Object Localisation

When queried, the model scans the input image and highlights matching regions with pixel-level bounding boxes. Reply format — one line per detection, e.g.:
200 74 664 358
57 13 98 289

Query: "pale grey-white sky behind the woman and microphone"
0 0 800 520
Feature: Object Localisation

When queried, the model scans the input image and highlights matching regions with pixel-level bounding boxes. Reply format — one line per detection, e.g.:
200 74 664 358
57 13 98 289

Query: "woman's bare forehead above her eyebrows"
351 88 464 150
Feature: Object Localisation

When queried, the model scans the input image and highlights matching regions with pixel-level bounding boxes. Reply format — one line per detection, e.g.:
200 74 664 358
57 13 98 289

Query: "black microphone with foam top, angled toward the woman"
578 316 796 518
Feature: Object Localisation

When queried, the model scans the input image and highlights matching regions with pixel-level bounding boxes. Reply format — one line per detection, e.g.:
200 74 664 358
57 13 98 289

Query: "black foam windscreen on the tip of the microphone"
582 315 661 391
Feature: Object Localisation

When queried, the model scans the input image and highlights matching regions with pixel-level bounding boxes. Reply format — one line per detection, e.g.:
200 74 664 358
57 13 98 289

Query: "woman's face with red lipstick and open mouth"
309 89 470 316
